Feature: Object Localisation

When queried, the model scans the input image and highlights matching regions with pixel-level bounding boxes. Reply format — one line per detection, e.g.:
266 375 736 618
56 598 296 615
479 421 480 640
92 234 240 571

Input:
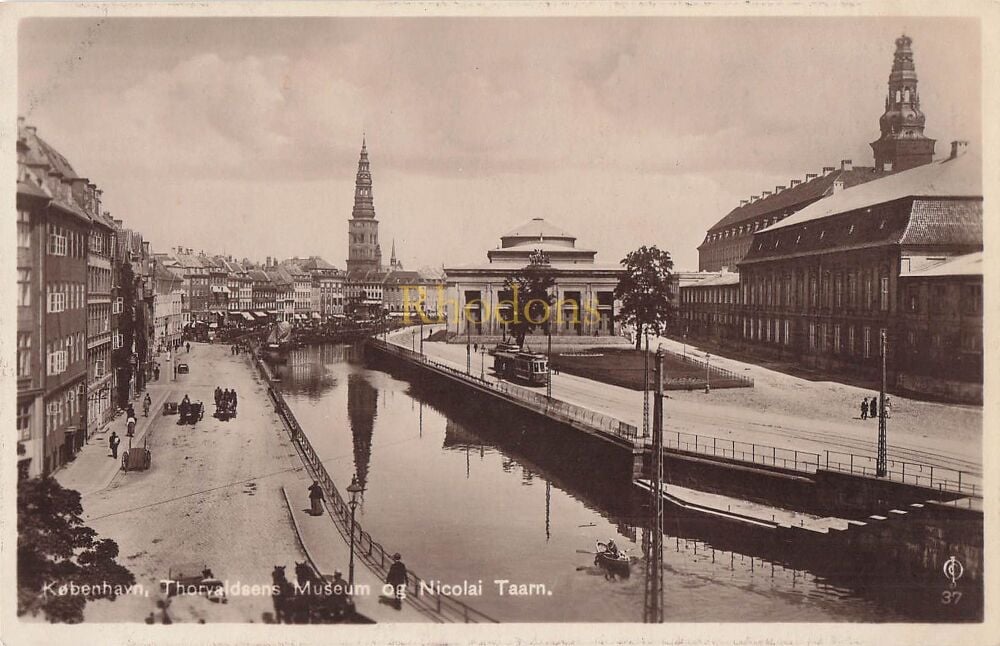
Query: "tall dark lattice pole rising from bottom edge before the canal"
643 346 665 624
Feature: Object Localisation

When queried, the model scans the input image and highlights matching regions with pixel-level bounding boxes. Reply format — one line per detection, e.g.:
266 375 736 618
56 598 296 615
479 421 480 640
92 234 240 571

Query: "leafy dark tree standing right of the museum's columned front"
615 246 674 350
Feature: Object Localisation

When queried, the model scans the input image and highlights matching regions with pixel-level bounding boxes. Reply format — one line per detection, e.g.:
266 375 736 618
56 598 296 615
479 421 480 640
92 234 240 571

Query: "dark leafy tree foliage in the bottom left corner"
17 478 135 623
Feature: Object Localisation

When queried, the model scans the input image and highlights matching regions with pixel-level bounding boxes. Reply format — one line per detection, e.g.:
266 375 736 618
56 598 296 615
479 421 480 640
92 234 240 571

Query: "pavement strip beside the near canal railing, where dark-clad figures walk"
284 486 432 624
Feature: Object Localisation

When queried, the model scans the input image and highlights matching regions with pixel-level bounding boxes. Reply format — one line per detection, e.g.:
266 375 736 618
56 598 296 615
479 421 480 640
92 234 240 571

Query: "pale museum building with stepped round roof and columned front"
445 218 623 338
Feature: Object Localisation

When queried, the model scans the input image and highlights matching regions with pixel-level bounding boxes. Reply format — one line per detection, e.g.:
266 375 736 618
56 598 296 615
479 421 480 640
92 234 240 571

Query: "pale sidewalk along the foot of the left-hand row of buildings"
54 388 174 496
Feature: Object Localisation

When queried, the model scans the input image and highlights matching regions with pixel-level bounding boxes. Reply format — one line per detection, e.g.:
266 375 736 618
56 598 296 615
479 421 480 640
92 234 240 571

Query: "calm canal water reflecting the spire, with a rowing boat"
275 345 958 622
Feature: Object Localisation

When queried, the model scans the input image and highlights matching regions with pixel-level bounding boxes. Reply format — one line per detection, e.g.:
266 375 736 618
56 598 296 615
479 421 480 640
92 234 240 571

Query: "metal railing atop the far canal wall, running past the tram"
368 339 639 443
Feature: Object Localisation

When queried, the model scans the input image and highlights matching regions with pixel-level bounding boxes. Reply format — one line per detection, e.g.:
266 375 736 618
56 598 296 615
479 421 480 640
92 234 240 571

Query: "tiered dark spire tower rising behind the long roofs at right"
871 34 934 171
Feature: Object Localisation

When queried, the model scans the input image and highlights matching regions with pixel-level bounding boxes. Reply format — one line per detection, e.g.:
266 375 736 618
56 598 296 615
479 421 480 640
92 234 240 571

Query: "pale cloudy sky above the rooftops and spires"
18 17 982 269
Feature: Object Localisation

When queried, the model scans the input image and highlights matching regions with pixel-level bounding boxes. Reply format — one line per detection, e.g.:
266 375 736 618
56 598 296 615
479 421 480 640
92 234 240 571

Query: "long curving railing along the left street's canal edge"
254 356 498 623
